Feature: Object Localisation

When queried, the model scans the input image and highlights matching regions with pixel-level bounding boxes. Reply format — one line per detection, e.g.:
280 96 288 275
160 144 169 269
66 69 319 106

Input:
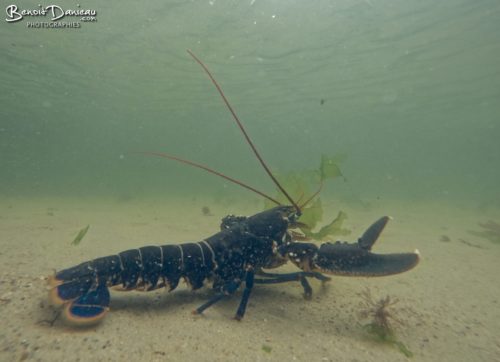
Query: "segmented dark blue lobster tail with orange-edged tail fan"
49 242 215 325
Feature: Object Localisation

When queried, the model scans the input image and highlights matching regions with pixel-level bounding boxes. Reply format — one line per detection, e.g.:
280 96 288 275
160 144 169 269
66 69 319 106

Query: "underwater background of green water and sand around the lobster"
0 0 500 362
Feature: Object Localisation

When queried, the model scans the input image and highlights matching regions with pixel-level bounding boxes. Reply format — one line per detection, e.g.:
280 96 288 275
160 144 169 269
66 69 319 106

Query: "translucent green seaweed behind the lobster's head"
265 155 351 240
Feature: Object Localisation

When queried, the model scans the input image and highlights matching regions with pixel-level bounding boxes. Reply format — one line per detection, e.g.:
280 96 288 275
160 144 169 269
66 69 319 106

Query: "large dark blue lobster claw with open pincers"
310 216 420 277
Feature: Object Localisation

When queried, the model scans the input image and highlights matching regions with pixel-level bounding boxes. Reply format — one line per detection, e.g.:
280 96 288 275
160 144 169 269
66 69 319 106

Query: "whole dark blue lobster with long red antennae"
48 50 419 325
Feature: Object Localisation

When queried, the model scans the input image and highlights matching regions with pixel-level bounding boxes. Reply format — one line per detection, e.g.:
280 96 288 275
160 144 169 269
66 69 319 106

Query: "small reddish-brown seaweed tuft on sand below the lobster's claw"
360 289 413 357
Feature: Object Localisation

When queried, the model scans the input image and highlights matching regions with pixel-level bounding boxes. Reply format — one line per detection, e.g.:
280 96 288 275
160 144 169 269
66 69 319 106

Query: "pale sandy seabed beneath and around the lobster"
0 198 500 361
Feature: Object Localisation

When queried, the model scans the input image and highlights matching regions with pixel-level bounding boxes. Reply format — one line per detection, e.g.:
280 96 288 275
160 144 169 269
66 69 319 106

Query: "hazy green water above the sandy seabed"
0 0 500 208
